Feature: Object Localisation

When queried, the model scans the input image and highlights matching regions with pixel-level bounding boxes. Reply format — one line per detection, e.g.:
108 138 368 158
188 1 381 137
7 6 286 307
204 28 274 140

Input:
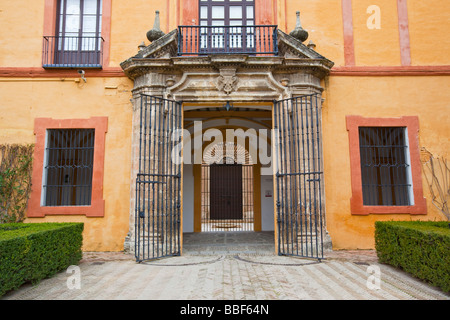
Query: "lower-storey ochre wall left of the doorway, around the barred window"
0 78 132 251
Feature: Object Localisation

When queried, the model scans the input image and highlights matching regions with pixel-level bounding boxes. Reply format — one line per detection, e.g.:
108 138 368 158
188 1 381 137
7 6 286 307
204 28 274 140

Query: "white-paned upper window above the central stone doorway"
199 0 255 52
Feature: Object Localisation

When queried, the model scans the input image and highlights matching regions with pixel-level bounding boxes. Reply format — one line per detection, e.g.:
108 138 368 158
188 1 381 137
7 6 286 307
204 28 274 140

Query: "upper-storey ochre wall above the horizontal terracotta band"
0 0 450 68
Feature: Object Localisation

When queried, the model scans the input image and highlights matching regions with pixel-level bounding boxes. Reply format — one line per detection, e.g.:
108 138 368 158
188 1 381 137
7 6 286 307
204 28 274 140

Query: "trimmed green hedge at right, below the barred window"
375 221 450 292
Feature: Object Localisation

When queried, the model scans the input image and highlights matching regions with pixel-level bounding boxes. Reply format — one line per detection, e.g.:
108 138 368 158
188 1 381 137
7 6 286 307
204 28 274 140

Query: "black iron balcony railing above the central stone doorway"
178 25 278 56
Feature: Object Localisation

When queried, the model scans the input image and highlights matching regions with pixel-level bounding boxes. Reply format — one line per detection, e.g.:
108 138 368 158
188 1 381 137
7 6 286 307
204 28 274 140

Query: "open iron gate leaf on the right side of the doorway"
274 94 324 260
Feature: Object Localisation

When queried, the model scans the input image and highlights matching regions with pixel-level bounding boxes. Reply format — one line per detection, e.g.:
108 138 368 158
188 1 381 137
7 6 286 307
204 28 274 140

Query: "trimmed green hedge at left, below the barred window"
0 223 84 296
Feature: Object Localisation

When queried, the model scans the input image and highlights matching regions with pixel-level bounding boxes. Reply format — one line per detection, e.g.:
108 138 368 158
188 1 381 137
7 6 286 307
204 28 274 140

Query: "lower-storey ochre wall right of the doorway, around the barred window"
323 77 450 249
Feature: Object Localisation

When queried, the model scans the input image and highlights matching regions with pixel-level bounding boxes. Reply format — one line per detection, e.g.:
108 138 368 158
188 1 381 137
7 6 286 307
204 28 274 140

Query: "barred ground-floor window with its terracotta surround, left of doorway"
27 117 108 218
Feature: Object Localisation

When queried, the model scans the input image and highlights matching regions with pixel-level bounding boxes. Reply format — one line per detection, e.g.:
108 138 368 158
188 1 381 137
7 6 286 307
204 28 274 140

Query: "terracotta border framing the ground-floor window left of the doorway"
27 117 108 218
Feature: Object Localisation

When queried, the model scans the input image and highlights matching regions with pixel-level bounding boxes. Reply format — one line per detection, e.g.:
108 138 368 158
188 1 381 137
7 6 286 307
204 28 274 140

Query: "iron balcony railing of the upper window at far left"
42 36 104 68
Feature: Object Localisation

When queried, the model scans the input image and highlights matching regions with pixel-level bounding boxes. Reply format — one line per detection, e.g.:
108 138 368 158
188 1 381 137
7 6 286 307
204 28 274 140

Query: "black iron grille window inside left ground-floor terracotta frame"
43 129 95 206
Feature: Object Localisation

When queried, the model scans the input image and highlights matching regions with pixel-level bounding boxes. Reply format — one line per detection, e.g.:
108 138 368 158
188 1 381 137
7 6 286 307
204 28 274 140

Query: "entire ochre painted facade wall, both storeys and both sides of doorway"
0 0 450 251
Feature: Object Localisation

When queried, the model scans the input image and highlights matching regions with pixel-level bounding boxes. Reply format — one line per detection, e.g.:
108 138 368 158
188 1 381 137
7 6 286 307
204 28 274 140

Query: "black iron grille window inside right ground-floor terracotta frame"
359 127 413 206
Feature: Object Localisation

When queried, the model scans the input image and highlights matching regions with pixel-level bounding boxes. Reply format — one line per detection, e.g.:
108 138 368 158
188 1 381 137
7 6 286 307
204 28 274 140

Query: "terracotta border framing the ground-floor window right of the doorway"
346 115 427 215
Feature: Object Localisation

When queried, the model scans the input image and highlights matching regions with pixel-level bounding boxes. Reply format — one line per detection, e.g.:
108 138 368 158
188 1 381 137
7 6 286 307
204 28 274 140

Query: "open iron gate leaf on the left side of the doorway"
135 95 182 262
